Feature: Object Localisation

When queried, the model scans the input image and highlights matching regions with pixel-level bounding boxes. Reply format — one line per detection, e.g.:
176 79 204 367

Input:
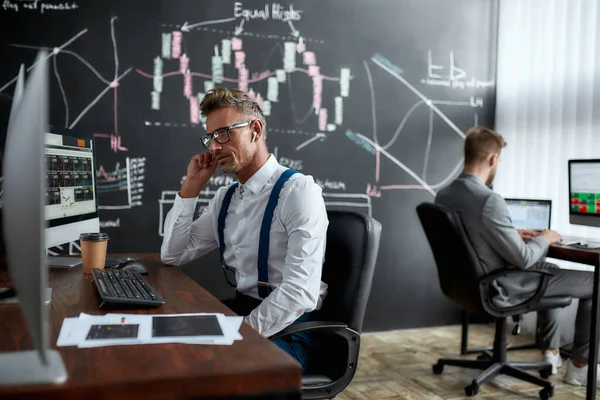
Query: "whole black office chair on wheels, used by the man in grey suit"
417 203 571 399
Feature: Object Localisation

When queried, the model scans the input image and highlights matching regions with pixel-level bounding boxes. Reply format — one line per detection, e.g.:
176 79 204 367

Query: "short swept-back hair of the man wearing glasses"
200 88 267 138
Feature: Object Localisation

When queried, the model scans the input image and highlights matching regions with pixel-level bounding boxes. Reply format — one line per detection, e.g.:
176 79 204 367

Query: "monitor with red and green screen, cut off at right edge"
568 159 600 227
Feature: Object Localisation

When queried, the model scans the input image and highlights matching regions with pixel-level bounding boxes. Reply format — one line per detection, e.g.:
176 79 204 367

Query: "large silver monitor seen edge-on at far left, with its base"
0 51 68 386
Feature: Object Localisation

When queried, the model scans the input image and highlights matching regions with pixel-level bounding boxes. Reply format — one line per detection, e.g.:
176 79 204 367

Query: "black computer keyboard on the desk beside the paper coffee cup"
92 269 165 309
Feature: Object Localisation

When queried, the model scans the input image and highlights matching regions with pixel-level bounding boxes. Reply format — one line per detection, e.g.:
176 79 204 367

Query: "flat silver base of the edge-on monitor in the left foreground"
0 350 67 387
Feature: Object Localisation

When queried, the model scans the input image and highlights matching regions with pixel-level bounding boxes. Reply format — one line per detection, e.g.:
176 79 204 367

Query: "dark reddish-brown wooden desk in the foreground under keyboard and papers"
0 254 301 400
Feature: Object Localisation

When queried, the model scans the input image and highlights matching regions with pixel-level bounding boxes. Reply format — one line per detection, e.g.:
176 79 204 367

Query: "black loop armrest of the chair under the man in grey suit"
479 268 554 316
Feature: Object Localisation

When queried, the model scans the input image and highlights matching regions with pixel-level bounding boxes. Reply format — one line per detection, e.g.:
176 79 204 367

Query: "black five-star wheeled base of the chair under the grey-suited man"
433 318 554 399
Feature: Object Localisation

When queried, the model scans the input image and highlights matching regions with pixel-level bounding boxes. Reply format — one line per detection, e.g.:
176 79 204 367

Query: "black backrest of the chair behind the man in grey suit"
417 203 486 312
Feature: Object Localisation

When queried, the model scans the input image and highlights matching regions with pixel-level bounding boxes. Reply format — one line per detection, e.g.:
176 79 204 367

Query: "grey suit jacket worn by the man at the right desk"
435 173 548 306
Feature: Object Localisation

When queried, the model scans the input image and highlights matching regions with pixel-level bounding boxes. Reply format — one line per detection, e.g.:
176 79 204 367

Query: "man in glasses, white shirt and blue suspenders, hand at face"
161 88 329 372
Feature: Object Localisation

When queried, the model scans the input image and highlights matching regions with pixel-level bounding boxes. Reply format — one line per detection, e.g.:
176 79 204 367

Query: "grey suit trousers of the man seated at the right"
531 262 594 363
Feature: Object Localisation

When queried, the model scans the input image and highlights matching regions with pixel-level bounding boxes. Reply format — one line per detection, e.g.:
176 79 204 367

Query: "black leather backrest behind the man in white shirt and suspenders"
318 210 381 333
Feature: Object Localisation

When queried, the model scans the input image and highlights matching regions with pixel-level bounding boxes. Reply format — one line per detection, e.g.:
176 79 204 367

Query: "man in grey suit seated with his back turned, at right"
435 127 597 385
